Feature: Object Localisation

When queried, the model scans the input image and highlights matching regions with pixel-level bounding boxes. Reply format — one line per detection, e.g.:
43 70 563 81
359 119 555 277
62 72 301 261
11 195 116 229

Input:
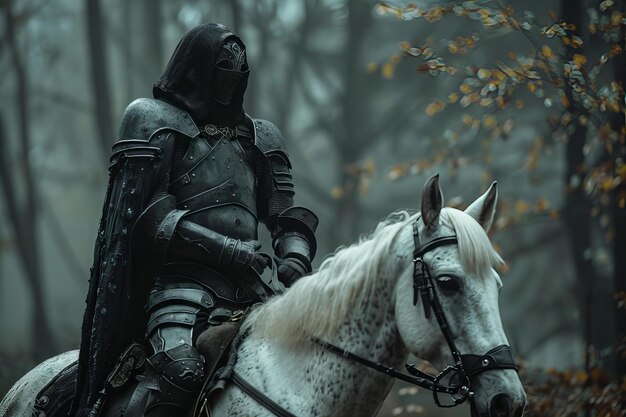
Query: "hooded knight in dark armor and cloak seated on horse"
71 24 317 417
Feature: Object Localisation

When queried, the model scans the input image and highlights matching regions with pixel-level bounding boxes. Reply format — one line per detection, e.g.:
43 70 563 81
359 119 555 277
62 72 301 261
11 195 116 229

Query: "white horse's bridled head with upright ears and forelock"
395 176 526 417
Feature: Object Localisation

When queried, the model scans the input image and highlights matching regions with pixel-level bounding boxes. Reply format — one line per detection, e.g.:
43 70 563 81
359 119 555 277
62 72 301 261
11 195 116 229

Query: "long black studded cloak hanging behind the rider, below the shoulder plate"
70 135 176 416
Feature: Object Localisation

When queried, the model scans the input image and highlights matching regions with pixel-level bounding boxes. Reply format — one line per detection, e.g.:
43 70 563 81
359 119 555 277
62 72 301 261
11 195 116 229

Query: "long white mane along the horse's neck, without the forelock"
244 211 415 341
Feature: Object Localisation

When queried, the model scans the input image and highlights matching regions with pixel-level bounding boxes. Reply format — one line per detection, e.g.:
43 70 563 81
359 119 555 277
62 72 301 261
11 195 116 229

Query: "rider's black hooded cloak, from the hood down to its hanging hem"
70 24 247 417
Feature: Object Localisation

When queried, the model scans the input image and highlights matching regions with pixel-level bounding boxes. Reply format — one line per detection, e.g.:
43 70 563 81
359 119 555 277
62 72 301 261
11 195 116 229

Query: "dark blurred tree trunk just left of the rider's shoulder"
86 0 115 158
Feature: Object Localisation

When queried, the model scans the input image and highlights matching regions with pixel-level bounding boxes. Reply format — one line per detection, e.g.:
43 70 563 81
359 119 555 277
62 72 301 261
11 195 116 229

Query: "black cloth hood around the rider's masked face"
152 23 248 128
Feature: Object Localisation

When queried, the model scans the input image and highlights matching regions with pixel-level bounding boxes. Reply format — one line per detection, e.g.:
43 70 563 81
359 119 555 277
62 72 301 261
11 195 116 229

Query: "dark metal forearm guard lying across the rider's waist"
133 194 253 271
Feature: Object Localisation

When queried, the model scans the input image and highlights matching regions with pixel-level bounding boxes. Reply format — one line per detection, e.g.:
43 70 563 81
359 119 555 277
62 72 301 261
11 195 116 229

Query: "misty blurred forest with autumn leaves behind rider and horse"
0 0 626 416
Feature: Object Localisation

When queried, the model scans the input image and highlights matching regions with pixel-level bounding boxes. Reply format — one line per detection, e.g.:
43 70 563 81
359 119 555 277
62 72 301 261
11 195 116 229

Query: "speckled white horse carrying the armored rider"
0 177 526 417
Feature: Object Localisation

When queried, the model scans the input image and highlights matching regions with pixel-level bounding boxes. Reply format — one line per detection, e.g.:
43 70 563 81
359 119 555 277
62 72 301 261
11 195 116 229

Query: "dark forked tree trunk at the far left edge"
0 0 55 360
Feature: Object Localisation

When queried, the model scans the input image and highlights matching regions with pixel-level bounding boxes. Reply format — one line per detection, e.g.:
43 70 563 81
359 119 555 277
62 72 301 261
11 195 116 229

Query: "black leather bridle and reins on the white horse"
225 217 518 417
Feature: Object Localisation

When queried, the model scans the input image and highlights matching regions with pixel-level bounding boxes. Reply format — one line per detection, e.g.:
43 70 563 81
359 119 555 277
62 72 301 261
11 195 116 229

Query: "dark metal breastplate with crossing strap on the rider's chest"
170 137 258 239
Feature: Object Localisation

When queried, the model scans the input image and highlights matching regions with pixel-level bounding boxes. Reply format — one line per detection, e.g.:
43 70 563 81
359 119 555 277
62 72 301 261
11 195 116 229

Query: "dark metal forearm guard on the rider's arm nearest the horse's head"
272 207 319 272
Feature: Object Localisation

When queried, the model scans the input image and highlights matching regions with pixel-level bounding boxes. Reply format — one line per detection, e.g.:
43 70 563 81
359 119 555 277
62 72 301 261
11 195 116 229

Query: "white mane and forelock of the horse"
242 207 503 342
